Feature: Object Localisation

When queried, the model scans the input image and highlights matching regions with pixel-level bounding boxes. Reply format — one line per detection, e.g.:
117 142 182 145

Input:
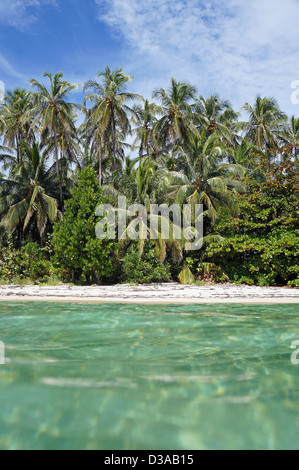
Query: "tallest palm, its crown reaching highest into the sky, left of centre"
84 66 141 170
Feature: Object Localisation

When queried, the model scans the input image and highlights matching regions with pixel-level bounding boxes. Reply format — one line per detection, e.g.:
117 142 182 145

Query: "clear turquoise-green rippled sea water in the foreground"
0 303 299 450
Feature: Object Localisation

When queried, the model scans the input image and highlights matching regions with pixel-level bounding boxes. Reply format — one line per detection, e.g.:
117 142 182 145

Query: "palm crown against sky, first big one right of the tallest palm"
153 78 196 145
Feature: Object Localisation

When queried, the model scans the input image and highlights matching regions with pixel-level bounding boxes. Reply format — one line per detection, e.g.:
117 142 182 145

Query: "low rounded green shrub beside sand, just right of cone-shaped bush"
122 243 171 284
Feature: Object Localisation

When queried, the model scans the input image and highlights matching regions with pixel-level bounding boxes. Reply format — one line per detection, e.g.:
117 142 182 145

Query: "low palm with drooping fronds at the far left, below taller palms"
0 143 58 237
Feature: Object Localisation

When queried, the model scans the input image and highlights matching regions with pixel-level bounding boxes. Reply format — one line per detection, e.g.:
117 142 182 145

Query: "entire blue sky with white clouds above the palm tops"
0 0 299 116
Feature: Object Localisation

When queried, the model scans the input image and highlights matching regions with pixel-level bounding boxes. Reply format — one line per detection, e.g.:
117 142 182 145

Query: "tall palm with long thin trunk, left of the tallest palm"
29 73 78 210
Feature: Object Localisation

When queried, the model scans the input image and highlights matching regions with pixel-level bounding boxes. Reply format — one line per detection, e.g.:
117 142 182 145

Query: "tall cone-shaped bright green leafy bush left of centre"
52 167 118 283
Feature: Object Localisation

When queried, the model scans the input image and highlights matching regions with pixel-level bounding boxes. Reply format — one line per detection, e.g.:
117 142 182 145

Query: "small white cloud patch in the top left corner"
0 0 55 28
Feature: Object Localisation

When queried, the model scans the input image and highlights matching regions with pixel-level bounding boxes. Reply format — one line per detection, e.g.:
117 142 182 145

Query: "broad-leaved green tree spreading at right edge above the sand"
206 162 299 286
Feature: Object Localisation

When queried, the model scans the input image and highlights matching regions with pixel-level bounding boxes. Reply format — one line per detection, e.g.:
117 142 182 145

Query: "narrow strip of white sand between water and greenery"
0 284 299 304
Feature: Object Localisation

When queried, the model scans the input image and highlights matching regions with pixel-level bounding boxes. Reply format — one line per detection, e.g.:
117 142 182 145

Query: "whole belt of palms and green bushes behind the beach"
0 67 299 286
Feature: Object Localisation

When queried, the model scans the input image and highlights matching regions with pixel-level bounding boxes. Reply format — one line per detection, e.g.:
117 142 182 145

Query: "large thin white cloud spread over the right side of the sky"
95 0 299 112
